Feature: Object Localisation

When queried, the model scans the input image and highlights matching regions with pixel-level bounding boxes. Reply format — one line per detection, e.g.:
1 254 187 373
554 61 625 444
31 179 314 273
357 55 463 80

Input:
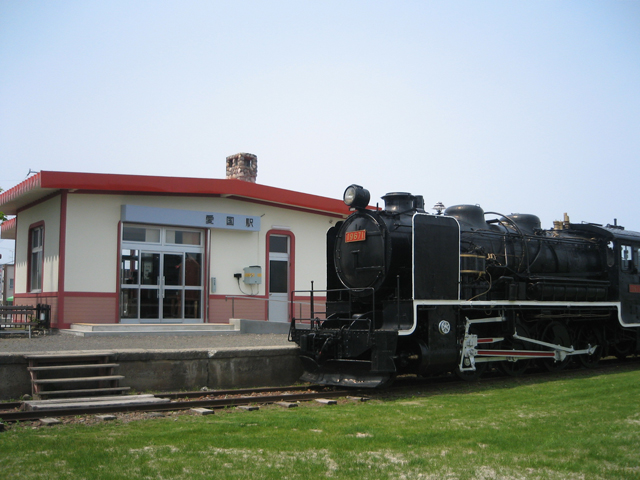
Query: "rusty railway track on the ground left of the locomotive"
0 386 358 422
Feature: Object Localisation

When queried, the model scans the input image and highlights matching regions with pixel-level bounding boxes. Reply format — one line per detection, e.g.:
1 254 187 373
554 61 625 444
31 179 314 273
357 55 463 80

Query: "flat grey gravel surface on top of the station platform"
0 333 295 354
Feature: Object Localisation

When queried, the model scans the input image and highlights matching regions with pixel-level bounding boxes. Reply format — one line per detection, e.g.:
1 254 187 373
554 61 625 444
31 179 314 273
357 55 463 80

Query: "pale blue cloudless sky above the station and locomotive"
0 0 640 262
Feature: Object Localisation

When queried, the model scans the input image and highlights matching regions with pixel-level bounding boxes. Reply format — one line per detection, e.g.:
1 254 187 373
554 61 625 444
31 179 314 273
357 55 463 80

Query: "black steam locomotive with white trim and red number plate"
290 185 640 387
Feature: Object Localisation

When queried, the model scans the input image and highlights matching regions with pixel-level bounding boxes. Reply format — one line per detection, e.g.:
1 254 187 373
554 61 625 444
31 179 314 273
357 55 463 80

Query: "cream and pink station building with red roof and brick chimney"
0 154 349 329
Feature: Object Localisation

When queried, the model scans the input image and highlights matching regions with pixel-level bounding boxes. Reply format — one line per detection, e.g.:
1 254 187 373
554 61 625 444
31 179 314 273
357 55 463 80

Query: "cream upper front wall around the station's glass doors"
62 193 336 295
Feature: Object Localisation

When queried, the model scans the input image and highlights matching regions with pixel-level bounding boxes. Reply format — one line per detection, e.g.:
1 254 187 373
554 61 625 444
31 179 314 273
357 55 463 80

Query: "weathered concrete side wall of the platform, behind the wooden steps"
0 346 302 400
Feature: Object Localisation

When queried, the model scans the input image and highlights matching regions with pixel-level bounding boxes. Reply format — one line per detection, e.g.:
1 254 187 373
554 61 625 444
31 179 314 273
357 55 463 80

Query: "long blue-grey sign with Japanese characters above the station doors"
120 205 260 232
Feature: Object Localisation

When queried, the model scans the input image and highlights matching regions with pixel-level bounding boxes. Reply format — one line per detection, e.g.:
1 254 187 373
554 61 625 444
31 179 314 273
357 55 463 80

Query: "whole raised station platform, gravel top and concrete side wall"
0 319 302 400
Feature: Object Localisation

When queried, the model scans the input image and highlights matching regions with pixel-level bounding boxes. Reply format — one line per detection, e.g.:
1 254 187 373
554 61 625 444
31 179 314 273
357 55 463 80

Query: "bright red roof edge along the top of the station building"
0 171 349 217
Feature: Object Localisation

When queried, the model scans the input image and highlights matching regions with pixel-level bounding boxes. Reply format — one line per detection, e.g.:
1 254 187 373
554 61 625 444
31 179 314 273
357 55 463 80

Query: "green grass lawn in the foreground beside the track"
0 365 640 480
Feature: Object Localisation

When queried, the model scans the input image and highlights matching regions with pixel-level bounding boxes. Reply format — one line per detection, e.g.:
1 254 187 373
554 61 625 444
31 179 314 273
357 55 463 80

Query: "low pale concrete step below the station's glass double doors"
60 323 240 337
